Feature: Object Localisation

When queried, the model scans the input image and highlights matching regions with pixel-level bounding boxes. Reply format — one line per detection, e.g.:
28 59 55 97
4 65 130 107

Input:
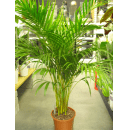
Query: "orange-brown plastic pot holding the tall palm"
51 107 76 130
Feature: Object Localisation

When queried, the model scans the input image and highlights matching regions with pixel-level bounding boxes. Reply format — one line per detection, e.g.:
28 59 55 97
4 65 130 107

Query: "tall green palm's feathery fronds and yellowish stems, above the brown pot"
15 0 110 115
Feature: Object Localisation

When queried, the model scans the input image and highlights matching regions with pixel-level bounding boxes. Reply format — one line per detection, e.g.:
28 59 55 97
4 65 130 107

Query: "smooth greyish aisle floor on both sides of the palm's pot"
15 71 113 130
